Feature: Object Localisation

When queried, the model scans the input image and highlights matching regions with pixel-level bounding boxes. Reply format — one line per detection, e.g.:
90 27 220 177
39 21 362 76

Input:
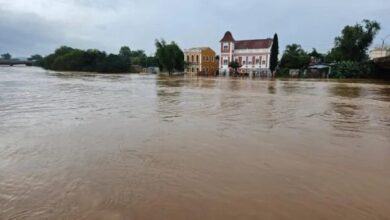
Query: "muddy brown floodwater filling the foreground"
0 67 390 220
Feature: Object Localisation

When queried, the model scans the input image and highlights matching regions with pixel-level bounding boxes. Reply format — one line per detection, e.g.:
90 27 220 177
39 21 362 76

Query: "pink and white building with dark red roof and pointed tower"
219 31 273 76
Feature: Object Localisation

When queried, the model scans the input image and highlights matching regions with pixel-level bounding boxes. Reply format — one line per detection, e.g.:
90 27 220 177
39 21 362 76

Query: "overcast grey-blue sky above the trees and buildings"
0 0 390 56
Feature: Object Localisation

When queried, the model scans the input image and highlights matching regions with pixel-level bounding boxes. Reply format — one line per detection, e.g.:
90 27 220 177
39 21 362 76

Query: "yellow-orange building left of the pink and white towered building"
184 47 218 76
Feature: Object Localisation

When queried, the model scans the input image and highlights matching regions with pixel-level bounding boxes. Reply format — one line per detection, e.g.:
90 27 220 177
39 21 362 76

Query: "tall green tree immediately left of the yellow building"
155 40 184 75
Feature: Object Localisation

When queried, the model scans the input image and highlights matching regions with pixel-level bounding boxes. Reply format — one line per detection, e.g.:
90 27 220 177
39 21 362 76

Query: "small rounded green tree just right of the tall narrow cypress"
280 44 310 69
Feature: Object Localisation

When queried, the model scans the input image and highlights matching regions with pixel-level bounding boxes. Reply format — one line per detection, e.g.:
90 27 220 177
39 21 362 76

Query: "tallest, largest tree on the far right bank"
330 20 381 62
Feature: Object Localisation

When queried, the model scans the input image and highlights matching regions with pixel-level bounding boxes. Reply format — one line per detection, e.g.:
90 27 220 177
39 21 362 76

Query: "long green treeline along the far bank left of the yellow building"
30 40 184 73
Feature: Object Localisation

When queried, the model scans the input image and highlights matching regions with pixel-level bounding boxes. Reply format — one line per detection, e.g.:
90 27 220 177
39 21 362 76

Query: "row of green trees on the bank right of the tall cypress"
278 20 381 78
